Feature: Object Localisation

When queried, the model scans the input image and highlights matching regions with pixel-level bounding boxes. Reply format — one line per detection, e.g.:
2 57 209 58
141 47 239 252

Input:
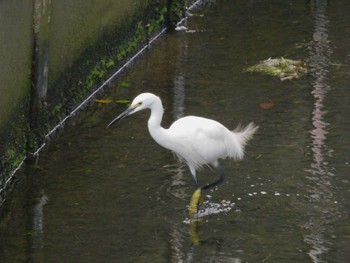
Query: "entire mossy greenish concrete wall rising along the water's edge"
0 0 192 206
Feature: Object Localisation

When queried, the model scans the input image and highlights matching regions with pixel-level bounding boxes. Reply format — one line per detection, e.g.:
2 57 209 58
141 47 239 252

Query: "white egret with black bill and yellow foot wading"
107 93 258 215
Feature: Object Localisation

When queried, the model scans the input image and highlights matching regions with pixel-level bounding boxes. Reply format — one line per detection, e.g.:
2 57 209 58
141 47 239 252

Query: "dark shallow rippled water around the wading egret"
0 0 350 262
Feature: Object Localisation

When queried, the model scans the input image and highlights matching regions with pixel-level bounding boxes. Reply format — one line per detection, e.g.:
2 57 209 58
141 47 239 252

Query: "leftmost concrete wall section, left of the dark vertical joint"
0 0 34 200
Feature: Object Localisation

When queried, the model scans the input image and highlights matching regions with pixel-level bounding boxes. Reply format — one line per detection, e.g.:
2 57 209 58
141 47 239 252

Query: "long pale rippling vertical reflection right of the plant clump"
304 0 336 262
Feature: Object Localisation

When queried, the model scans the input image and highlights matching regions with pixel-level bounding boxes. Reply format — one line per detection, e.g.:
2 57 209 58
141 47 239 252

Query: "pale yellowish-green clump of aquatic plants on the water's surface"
245 57 309 81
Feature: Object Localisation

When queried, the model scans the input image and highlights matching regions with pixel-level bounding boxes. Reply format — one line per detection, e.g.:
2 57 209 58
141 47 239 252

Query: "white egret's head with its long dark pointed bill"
107 93 160 128
